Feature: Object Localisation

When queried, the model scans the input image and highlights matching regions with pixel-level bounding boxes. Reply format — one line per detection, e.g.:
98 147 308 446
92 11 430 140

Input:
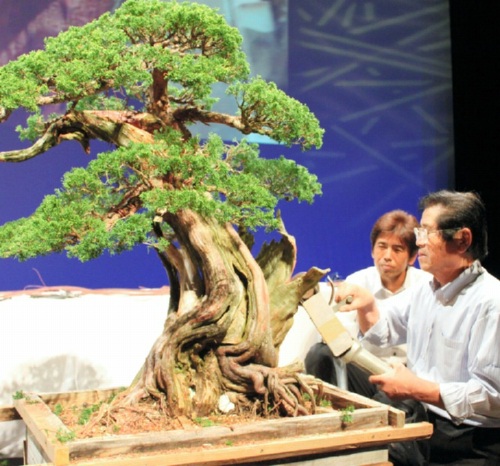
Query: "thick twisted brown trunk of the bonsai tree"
119 210 324 416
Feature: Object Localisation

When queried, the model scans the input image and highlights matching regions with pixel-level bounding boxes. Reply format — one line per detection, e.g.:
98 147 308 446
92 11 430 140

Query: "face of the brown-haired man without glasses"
372 233 415 285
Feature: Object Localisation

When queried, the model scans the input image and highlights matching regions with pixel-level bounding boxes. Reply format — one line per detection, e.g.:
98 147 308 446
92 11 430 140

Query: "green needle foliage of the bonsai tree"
0 0 323 261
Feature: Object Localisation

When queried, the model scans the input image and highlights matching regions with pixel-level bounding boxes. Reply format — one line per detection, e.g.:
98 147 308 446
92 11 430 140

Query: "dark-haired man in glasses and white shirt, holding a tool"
336 191 500 465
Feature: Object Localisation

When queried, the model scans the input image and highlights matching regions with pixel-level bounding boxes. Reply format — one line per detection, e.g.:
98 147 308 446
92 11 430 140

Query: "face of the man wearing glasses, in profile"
417 205 455 278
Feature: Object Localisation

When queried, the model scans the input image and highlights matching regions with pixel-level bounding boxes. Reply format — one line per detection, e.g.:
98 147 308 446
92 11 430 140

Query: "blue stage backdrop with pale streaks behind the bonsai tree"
0 0 494 290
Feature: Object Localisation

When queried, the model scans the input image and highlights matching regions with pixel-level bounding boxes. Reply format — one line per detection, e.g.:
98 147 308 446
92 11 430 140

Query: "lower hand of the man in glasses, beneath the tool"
368 363 444 408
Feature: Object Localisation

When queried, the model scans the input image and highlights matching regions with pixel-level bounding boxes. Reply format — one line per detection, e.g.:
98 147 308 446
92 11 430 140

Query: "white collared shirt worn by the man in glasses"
364 261 500 427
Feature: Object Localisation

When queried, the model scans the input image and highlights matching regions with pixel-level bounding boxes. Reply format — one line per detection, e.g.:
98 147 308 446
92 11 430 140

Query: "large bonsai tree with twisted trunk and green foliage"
0 0 326 422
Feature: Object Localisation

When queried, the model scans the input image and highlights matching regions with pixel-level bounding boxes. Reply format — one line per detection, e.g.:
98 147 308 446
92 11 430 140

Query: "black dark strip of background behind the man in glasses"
450 0 500 278
